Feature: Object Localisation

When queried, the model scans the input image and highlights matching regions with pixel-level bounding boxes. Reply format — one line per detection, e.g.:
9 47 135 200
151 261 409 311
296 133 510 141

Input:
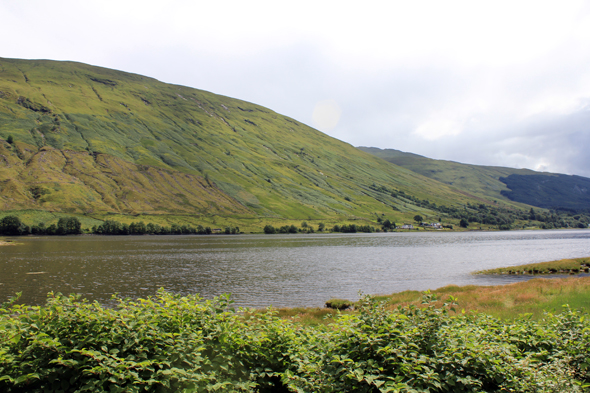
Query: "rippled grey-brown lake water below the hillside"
0 230 590 307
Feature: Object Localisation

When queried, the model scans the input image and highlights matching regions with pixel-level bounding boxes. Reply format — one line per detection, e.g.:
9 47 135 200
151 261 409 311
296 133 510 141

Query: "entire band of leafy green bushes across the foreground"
0 291 590 392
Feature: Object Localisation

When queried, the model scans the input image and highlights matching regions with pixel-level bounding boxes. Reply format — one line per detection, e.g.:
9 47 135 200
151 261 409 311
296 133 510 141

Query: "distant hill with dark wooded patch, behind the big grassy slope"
359 147 590 211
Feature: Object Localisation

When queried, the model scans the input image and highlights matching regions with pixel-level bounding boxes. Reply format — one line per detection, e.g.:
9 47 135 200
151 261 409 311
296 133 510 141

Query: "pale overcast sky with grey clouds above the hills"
0 0 590 177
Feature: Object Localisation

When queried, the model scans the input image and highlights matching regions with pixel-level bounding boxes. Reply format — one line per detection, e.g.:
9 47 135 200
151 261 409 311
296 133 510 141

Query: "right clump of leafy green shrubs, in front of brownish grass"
283 295 588 392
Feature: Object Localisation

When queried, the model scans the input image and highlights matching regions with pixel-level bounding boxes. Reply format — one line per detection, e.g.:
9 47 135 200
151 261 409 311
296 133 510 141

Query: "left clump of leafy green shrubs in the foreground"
0 291 289 392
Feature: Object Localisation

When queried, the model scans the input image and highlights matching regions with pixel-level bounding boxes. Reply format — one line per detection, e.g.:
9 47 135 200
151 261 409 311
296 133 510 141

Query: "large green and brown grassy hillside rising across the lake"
0 59 481 226
